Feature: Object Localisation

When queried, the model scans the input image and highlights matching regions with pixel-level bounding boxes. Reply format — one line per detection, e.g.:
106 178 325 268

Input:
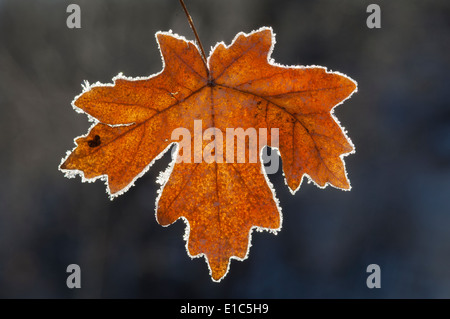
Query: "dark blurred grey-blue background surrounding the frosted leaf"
0 0 450 298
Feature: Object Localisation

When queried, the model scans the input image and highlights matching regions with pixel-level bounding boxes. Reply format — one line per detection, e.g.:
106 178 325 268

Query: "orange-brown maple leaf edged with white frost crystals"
60 27 356 281
